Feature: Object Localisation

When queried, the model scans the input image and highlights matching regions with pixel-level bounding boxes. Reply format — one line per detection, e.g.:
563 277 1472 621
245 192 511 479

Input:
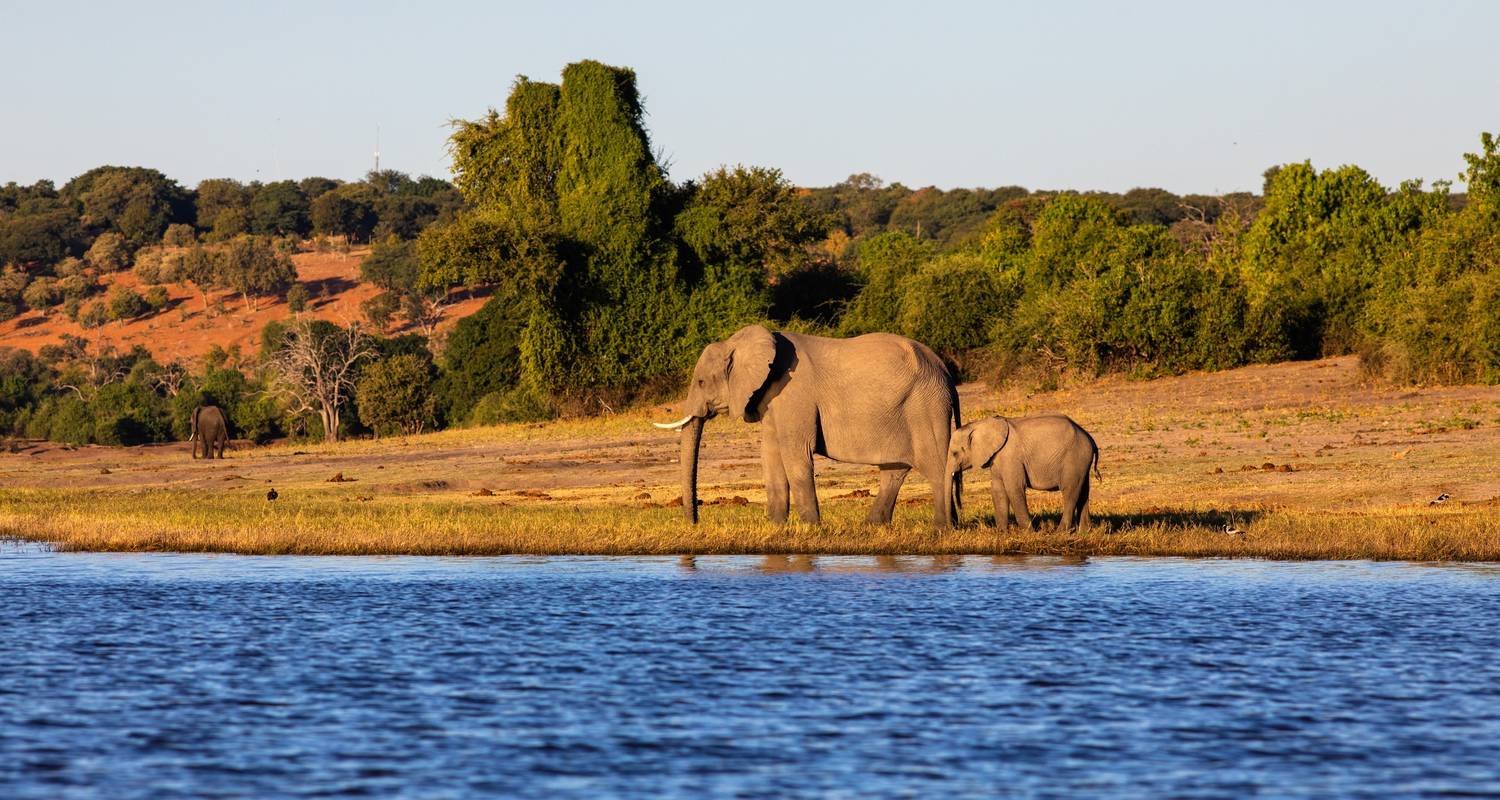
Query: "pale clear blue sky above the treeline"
0 0 1500 192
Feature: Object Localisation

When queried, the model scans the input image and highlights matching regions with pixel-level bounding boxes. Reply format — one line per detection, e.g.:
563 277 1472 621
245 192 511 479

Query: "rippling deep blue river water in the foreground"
0 545 1500 798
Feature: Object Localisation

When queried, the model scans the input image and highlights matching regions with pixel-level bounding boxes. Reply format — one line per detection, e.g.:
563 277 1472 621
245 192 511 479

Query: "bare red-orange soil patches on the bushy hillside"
0 249 485 362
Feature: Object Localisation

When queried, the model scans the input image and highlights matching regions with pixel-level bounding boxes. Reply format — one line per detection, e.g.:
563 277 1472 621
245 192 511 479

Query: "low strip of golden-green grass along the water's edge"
0 489 1500 561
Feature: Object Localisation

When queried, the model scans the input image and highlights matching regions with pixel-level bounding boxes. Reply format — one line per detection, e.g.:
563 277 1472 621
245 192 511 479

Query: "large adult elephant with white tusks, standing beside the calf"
654 326 959 527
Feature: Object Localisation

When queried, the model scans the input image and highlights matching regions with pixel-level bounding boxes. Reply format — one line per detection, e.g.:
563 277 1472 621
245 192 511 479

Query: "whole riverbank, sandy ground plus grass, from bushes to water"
0 359 1500 561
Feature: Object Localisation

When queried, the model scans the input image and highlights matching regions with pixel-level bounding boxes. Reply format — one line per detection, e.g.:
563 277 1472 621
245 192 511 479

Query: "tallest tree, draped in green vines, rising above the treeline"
435 62 698 395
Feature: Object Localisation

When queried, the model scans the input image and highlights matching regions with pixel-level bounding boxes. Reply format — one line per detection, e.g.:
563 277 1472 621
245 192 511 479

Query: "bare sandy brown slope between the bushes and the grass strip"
0 357 1500 515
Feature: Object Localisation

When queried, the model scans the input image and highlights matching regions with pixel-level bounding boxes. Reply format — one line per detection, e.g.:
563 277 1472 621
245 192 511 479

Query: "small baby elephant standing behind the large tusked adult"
947 414 1100 530
